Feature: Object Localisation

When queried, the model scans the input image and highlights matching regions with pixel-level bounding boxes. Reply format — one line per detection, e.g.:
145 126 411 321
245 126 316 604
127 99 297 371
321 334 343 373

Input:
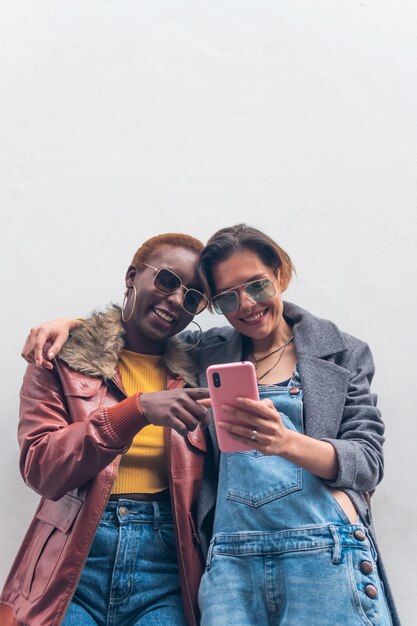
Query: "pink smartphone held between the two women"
207 361 259 452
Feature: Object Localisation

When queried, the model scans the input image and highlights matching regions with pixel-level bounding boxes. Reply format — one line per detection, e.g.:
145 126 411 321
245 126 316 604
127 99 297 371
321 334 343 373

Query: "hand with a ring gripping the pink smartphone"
218 398 293 455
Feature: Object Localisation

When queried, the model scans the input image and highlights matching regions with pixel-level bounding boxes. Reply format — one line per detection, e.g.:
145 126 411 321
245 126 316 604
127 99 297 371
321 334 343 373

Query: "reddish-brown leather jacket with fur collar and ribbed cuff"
0 308 206 626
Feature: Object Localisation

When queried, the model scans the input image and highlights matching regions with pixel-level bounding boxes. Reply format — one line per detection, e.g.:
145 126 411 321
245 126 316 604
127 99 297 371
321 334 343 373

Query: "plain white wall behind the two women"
0 0 417 624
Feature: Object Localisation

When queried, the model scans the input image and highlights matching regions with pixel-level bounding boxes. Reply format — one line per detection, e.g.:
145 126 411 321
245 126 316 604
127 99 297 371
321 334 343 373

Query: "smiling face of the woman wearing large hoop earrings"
124 245 202 354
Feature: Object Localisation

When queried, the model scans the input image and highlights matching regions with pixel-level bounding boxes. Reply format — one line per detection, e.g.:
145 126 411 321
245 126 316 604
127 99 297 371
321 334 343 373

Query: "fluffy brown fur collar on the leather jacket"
59 305 196 386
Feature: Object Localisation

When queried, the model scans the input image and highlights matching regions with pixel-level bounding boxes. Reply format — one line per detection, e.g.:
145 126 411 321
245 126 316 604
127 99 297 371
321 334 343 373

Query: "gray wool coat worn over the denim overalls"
184 302 400 626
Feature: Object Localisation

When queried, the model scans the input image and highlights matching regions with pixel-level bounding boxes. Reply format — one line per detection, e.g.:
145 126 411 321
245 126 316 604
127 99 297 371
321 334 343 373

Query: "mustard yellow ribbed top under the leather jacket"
111 350 168 494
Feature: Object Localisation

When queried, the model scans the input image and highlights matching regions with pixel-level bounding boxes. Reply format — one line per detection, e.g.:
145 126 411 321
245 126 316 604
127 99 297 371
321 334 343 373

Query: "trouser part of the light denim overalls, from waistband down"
199 524 391 626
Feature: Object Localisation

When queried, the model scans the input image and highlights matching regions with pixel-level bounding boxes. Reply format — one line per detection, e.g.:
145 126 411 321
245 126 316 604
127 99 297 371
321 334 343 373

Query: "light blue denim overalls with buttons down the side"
199 373 391 626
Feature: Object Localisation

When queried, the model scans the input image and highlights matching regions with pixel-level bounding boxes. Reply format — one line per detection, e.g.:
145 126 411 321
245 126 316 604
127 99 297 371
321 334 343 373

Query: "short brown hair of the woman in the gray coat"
199 224 295 294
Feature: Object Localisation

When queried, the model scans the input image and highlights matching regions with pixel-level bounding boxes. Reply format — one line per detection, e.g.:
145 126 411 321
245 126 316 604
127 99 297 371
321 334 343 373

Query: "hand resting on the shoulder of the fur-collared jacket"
21 317 83 370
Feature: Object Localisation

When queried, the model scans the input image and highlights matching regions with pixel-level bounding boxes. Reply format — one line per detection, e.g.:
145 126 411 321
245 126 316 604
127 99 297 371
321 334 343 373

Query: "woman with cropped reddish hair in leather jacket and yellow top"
0 234 208 626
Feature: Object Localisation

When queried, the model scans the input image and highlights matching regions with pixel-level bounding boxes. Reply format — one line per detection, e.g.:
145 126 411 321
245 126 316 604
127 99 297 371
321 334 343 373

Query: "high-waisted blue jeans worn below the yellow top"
62 500 186 626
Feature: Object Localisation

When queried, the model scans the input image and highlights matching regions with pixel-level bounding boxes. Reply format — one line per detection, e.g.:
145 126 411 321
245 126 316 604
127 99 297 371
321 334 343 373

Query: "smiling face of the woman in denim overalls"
212 249 290 346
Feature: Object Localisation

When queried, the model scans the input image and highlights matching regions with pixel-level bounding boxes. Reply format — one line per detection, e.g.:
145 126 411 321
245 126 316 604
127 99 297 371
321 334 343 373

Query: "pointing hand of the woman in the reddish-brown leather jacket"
139 388 210 435
